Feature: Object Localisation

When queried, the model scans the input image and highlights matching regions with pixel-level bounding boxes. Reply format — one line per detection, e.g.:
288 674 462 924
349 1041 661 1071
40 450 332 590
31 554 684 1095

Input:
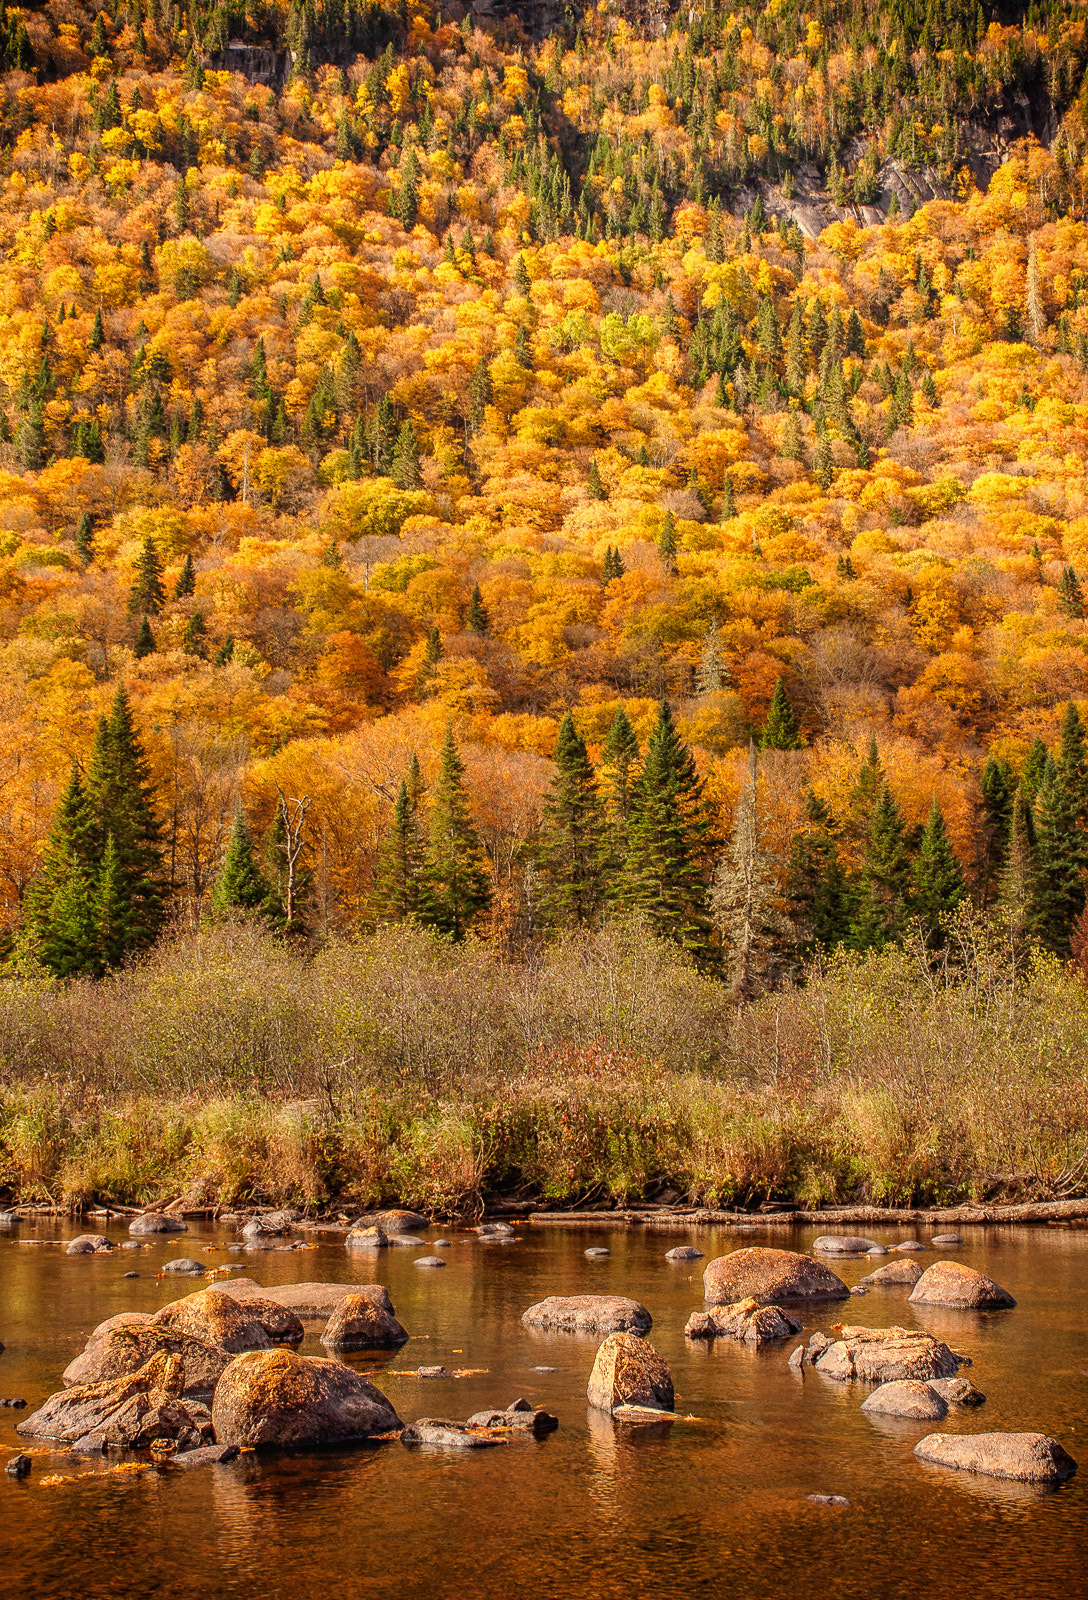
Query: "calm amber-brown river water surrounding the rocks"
0 1224 1088 1600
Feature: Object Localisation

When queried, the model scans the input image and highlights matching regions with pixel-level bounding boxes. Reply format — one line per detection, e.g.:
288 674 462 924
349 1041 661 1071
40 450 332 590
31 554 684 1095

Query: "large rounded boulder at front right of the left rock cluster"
211 1349 400 1448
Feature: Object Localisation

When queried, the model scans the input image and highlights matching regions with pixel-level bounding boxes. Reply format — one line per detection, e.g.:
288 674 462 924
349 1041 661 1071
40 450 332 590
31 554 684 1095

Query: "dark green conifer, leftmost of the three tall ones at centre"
536 712 605 928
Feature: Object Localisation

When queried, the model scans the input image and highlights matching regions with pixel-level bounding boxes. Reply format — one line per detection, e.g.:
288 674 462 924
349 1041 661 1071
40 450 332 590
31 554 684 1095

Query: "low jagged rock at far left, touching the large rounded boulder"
16 1350 211 1450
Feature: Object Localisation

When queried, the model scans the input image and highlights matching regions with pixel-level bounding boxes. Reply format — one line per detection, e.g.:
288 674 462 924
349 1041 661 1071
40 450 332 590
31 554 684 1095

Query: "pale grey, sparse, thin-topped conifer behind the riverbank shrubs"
710 744 782 1000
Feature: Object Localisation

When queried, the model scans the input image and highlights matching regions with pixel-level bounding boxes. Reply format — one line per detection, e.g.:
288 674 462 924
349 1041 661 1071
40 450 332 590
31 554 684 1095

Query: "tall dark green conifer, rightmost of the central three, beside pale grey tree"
622 701 710 960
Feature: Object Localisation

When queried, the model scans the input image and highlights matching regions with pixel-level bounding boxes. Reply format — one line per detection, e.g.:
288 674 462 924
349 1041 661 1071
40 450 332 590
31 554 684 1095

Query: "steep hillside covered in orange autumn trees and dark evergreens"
0 0 1088 992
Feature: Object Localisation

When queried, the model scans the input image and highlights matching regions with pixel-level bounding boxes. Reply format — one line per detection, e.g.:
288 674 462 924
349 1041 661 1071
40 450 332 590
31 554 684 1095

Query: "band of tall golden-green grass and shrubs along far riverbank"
0 917 1088 1213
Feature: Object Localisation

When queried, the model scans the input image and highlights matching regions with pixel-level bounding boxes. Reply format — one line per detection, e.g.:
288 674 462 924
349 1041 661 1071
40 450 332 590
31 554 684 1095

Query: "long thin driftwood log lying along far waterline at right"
526 1198 1088 1229
